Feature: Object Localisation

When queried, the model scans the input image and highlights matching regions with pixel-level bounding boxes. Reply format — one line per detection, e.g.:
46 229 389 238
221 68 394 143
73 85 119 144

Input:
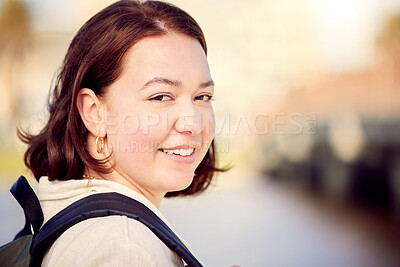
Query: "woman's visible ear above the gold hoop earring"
76 88 106 137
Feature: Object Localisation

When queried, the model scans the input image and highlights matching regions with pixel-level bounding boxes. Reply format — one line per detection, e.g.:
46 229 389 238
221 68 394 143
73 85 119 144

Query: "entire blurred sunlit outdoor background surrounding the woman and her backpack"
0 0 400 267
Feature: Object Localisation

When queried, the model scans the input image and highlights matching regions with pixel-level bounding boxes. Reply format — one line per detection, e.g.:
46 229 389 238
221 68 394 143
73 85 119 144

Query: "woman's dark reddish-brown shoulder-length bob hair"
18 0 223 197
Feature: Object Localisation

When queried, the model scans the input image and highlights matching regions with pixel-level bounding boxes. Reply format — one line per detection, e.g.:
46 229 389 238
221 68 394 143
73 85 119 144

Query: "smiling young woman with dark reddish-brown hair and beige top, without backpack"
19 1 220 266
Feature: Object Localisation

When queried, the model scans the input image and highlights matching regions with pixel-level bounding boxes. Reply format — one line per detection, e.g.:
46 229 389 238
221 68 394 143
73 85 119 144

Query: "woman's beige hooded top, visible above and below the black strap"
37 177 183 267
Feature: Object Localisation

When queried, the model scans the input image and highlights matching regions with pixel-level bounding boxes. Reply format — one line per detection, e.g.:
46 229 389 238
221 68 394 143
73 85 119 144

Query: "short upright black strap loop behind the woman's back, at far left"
10 175 43 240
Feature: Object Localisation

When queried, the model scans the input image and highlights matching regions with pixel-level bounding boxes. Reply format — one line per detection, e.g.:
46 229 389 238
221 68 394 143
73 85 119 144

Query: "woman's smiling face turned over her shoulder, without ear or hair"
106 33 215 205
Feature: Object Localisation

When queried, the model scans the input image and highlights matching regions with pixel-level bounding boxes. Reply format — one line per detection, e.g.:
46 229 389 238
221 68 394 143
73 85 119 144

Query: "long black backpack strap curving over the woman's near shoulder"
31 193 202 267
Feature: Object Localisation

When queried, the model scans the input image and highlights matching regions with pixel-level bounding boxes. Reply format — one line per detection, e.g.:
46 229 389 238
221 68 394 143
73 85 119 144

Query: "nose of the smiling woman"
175 104 204 135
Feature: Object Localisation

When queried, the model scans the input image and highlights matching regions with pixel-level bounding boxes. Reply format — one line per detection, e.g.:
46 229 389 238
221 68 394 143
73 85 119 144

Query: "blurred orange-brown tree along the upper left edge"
0 0 32 138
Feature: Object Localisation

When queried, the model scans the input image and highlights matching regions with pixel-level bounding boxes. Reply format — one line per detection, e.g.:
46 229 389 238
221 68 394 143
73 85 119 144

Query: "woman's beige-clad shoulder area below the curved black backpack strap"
43 216 183 266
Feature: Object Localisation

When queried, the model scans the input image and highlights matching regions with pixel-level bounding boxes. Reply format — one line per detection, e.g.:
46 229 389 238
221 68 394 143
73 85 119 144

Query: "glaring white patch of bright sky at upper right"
311 0 400 70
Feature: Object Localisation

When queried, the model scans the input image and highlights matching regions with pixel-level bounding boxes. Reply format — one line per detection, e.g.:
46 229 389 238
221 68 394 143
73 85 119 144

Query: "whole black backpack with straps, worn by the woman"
0 176 202 267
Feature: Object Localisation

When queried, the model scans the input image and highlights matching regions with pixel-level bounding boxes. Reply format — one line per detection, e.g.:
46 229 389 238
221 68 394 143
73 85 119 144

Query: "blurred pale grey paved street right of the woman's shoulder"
161 174 398 267
